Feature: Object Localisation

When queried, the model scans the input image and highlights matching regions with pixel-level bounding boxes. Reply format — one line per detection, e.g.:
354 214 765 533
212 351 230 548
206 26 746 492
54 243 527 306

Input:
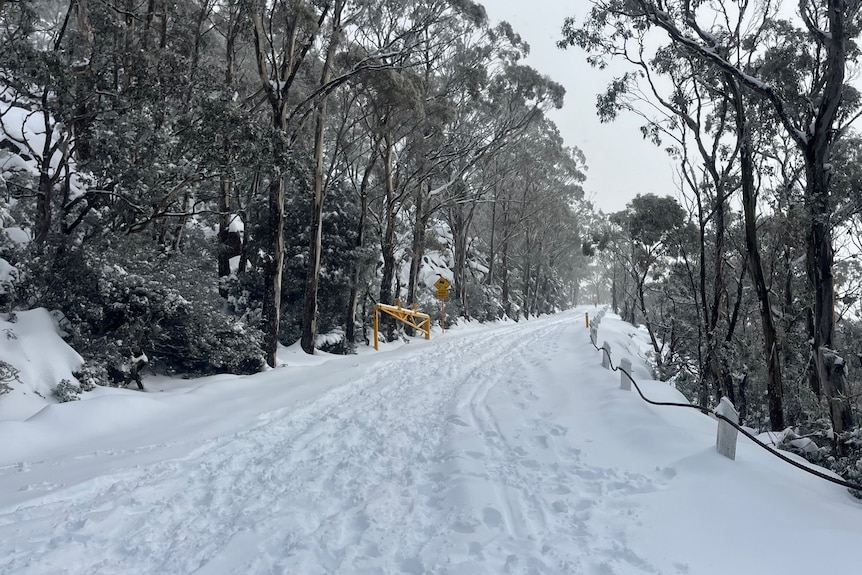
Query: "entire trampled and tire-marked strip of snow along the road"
0 315 676 575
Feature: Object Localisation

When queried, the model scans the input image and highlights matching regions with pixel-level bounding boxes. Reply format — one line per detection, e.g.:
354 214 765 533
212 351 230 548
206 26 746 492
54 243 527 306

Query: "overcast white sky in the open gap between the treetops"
479 0 676 213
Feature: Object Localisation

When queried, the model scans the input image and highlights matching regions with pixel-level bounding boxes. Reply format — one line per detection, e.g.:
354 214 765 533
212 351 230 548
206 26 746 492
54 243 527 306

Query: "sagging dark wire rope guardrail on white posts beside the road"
588 309 862 493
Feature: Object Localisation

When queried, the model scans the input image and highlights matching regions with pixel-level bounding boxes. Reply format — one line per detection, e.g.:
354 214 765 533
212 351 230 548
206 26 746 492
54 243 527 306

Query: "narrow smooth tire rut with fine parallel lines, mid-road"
412 317 579 573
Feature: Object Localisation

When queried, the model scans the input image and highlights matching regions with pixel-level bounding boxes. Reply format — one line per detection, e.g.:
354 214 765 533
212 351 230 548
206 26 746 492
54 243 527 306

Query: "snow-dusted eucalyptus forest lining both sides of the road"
0 0 862 490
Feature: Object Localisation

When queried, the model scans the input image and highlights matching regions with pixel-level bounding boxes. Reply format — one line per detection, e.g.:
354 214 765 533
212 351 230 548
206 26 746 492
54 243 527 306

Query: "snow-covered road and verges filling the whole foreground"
0 309 862 575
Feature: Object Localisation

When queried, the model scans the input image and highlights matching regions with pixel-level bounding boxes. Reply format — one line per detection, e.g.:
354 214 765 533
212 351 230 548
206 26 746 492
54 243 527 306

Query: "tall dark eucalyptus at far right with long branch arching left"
566 0 860 433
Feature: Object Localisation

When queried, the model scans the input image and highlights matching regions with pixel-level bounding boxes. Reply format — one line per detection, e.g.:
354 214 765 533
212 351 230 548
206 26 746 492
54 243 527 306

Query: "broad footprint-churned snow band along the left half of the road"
0 318 572 573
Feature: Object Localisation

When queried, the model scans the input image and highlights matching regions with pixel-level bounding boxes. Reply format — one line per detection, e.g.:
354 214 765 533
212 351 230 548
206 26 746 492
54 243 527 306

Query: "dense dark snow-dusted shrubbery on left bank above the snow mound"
12 231 263 380
